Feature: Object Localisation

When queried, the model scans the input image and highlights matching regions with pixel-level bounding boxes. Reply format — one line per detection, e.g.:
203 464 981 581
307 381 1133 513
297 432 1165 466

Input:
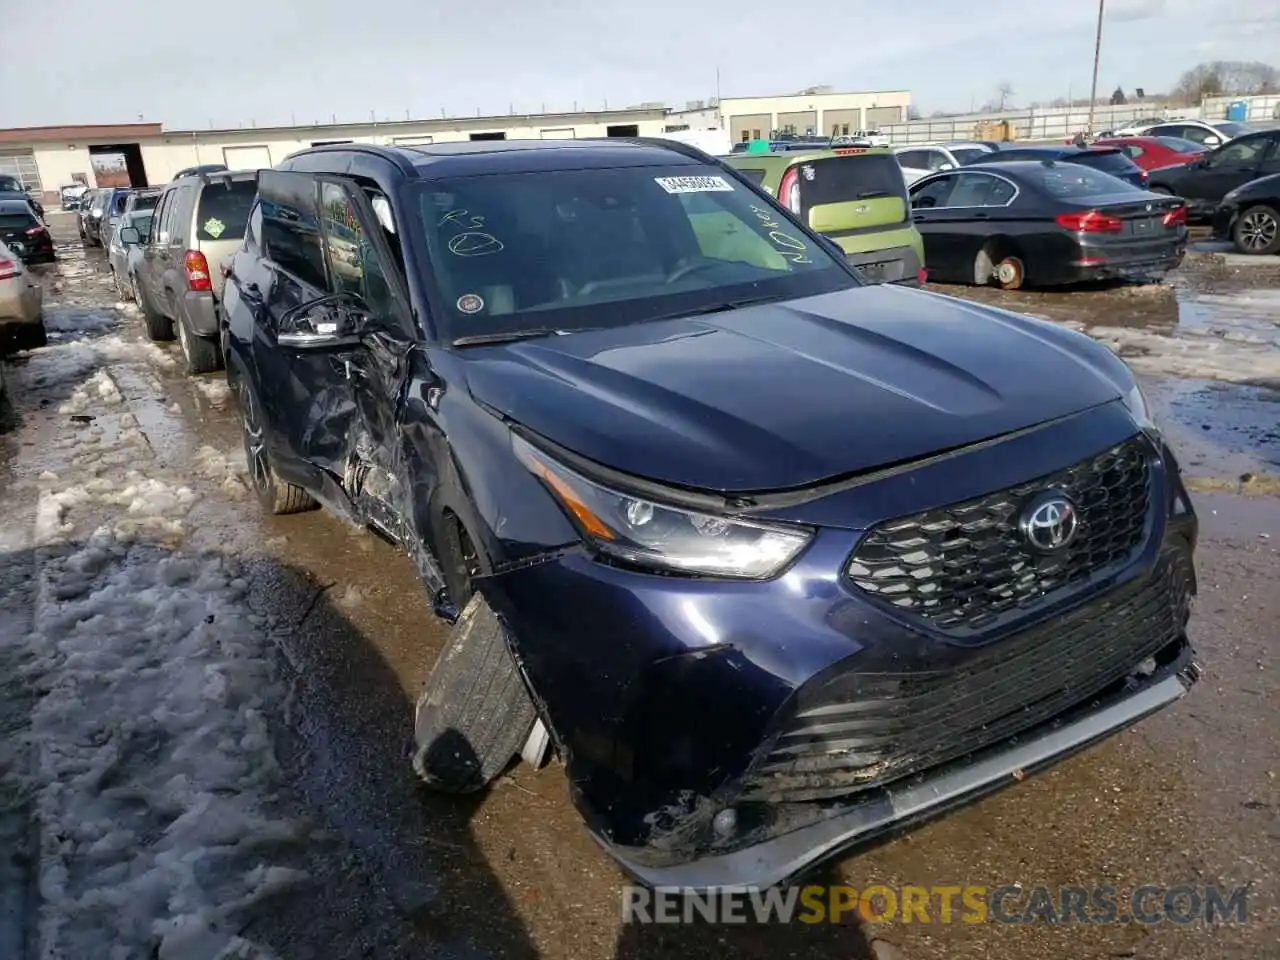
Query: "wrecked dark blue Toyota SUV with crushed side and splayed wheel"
224 140 1198 890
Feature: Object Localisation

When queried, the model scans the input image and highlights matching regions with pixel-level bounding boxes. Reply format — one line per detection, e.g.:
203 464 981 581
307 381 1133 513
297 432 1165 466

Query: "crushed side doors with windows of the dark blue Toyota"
255 170 415 527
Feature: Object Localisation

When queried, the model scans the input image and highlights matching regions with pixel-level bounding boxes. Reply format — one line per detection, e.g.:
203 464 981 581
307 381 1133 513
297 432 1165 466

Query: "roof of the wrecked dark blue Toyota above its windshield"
285 137 707 180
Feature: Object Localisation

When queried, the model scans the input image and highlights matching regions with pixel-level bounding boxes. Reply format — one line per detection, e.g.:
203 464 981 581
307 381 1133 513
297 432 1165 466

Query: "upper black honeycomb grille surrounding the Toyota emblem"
847 436 1152 631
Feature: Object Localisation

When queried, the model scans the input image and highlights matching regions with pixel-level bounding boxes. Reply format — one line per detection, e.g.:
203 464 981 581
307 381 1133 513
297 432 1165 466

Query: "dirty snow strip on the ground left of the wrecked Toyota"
13 338 310 960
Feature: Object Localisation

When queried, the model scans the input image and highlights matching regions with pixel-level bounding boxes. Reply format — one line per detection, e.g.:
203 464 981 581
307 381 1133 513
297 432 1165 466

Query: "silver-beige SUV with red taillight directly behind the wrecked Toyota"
129 170 257 374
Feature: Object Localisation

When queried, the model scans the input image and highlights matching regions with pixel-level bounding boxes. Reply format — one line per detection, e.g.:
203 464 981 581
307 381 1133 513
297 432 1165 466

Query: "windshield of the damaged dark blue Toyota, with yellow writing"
412 164 859 340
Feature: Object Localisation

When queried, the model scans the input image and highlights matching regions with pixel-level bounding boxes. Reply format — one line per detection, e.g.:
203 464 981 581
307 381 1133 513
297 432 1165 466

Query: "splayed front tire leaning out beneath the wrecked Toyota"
413 593 538 794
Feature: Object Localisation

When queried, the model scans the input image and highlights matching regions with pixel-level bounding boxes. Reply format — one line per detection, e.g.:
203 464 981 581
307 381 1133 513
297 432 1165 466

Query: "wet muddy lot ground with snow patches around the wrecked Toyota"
0 216 1280 960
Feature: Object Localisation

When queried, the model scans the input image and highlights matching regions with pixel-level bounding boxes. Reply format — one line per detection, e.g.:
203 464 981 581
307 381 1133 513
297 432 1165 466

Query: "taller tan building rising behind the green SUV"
719 87 911 143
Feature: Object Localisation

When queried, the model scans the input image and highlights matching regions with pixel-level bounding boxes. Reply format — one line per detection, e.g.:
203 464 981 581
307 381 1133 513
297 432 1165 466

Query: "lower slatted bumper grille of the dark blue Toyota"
744 553 1192 803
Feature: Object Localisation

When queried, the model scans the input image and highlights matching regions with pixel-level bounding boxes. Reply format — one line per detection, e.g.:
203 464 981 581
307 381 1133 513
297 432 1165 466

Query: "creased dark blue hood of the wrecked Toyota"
461 285 1121 492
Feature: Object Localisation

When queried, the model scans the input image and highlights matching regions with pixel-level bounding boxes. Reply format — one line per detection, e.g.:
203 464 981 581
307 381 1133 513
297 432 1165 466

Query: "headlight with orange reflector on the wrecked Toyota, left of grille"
512 435 813 580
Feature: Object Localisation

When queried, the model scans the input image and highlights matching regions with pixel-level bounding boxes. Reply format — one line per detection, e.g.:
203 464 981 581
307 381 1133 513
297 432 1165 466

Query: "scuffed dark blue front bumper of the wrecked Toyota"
484 404 1196 888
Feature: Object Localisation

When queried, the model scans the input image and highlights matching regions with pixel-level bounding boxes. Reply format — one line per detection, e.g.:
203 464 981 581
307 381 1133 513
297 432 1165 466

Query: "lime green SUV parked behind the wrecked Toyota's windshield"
722 145 925 287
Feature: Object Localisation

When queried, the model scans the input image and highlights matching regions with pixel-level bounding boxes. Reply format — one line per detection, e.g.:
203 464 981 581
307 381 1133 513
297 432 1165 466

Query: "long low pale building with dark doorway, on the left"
0 105 667 201
